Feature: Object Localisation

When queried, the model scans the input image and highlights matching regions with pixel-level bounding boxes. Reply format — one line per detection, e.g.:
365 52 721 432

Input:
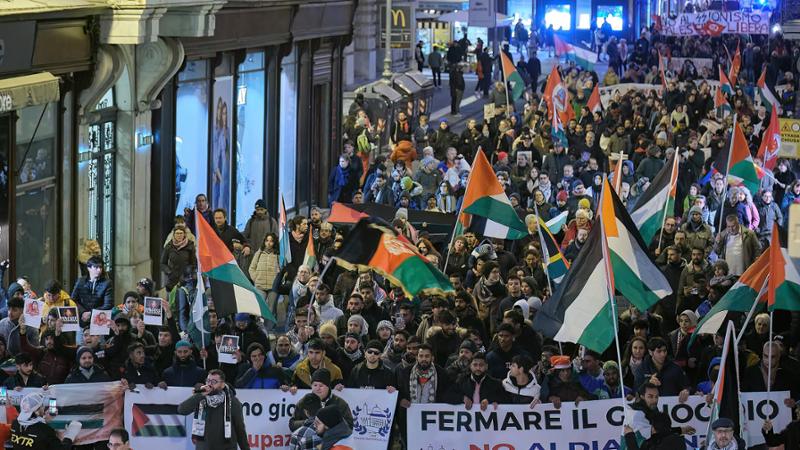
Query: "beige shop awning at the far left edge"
0 72 59 113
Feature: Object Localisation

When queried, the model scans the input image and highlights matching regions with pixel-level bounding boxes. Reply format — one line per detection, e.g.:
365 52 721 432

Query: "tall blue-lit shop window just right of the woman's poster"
235 52 265 230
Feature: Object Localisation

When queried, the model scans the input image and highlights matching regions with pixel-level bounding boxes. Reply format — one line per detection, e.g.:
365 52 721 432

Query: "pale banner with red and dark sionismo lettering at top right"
661 10 770 36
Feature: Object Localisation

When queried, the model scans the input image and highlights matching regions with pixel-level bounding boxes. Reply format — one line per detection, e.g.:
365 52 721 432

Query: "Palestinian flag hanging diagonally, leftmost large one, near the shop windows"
195 212 275 322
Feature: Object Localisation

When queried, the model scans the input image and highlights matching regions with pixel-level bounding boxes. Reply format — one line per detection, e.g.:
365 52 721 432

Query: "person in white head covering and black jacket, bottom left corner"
11 392 81 450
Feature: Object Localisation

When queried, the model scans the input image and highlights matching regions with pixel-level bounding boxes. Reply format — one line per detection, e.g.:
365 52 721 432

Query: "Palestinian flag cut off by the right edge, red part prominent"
767 223 800 311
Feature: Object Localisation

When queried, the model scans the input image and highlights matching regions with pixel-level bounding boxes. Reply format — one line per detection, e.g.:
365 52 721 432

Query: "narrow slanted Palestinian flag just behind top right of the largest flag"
631 158 678 248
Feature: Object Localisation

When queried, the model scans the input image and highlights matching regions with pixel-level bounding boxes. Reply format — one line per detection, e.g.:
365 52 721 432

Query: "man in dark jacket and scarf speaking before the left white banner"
178 369 250 450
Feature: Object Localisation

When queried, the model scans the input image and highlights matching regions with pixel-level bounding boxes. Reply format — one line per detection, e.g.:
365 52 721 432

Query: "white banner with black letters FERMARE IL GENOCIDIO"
408 391 791 450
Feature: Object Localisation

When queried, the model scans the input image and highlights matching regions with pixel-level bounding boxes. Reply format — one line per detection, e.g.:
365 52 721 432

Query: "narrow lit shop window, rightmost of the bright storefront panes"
278 49 297 209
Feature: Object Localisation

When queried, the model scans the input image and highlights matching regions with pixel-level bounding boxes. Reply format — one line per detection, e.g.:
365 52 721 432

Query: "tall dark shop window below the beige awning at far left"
13 103 58 286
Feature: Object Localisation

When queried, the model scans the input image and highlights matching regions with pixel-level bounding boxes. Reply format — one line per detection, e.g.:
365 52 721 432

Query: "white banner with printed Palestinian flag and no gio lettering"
125 387 397 450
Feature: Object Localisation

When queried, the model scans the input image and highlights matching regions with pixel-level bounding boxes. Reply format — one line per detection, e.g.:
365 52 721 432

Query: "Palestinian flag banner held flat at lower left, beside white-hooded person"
48 382 125 445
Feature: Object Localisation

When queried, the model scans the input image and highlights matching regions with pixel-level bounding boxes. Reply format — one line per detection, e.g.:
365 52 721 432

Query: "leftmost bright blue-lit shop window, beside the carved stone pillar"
175 60 209 215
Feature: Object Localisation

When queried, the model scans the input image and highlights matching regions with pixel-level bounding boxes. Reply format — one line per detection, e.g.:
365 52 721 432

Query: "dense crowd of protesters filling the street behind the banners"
0 18 800 449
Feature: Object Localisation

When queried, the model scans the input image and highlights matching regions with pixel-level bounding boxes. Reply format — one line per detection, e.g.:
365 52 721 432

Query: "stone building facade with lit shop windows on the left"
0 0 355 297
